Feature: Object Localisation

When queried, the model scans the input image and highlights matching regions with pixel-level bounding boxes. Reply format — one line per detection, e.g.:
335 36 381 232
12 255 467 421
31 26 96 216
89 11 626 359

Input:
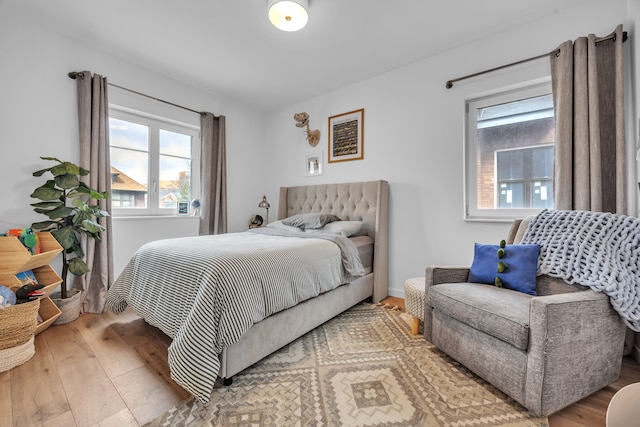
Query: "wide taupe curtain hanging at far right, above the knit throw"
551 25 627 214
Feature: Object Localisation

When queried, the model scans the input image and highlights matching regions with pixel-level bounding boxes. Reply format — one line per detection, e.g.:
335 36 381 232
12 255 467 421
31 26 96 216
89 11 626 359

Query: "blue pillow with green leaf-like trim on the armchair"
469 243 540 296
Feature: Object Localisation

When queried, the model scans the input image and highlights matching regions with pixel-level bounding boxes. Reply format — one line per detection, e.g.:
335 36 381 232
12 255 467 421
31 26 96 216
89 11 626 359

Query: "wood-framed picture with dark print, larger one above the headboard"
329 108 364 163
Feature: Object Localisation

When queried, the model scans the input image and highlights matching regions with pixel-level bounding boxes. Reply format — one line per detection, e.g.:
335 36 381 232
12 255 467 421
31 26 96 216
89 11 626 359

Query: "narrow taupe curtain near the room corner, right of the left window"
200 113 227 235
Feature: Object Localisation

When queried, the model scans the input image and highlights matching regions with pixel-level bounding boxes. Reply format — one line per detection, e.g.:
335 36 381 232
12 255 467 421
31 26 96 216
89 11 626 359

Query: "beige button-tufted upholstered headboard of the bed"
278 180 389 302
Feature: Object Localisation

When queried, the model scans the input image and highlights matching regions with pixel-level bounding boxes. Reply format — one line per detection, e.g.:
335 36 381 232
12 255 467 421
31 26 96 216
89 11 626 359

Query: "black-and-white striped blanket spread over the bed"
106 232 362 402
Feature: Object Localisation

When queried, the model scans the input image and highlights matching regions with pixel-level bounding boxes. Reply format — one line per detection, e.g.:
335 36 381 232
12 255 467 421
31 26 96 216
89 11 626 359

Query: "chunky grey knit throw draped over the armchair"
522 210 640 332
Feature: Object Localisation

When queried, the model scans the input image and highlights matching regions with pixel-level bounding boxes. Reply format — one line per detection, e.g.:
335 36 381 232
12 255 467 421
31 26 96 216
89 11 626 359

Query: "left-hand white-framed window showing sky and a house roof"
109 108 200 215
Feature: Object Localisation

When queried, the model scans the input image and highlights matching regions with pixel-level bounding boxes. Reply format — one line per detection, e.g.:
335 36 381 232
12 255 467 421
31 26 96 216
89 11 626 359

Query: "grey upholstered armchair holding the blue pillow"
424 220 626 416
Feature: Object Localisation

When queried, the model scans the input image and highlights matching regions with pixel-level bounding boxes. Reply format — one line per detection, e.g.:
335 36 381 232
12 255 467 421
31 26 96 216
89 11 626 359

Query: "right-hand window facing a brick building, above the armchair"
465 83 555 220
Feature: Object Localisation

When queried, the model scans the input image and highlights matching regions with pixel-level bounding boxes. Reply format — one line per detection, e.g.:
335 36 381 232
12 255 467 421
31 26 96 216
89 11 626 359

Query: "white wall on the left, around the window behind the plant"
0 6 265 274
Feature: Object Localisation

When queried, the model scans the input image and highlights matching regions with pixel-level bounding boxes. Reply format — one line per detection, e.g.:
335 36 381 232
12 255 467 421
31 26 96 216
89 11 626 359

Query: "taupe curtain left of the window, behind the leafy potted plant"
74 71 114 313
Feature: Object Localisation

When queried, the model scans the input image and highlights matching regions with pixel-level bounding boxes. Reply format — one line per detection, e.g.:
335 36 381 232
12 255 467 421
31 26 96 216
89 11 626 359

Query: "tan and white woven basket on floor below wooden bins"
0 300 40 372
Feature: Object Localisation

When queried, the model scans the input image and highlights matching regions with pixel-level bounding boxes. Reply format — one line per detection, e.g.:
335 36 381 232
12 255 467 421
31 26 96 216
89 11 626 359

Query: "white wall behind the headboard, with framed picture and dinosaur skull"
266 0 631 296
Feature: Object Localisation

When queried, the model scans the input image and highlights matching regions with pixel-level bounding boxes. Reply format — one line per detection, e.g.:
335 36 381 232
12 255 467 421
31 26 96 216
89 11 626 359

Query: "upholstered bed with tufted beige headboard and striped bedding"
106 180 389 402
